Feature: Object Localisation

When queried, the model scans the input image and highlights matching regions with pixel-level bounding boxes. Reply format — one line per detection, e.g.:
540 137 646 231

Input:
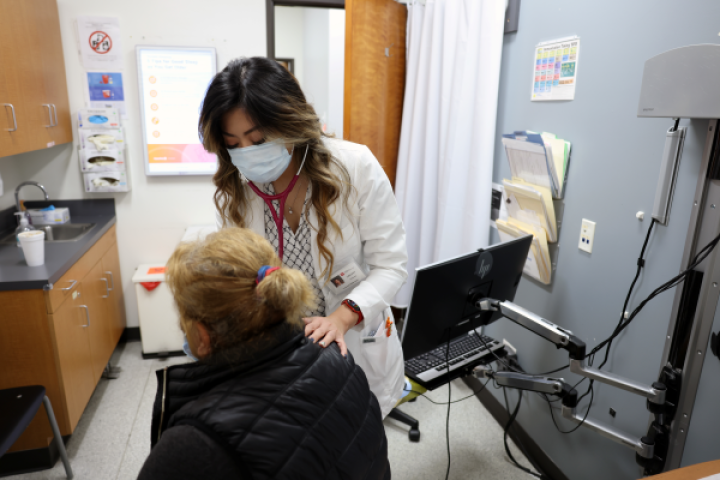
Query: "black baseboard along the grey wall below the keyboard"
463 377 568 480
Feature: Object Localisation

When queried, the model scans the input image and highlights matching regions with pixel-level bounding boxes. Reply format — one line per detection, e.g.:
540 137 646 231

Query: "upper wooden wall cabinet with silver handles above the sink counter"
0 0 72 157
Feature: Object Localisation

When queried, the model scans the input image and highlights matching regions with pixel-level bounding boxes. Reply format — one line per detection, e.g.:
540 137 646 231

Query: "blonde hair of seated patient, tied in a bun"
167 228 315 353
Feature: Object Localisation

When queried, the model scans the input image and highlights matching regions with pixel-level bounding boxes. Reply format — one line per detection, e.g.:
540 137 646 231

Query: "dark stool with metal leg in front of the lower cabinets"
0 385 73 478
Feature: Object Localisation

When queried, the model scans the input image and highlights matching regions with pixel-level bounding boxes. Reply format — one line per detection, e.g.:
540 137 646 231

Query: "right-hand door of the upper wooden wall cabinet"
33 0 72 147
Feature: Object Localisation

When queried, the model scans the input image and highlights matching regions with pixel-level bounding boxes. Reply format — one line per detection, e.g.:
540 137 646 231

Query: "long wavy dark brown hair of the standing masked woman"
198 57 350 277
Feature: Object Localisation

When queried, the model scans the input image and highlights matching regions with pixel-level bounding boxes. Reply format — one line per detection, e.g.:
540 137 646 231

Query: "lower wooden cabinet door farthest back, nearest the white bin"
82 262 115 383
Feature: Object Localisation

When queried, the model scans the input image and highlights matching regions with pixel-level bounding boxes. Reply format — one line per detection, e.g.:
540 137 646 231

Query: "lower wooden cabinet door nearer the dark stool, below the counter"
50 284 97 433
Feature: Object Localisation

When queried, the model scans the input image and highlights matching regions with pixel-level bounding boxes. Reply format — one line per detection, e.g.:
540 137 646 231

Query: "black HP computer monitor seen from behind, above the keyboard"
401 235 533 360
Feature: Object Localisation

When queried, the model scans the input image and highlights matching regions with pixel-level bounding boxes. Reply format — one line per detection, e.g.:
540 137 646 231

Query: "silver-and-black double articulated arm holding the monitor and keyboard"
474 298 666 464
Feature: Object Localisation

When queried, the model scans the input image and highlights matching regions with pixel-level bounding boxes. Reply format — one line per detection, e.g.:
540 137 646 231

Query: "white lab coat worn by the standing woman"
217 138 407 417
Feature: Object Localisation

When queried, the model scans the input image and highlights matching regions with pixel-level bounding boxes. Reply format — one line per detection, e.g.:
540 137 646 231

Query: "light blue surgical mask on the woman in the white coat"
228 142 292 183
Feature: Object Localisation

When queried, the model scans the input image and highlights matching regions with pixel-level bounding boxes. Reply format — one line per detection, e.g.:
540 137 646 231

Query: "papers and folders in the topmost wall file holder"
502 131 571 198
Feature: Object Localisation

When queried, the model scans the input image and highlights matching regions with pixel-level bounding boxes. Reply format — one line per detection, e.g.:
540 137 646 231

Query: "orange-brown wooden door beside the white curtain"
343 0 407 185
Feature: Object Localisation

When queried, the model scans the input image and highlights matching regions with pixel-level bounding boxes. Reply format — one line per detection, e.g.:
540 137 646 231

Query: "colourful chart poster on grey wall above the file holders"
530 37 580 102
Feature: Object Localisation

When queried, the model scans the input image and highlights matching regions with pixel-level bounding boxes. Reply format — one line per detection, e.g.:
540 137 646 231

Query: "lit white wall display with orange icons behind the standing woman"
137 46 217 175
